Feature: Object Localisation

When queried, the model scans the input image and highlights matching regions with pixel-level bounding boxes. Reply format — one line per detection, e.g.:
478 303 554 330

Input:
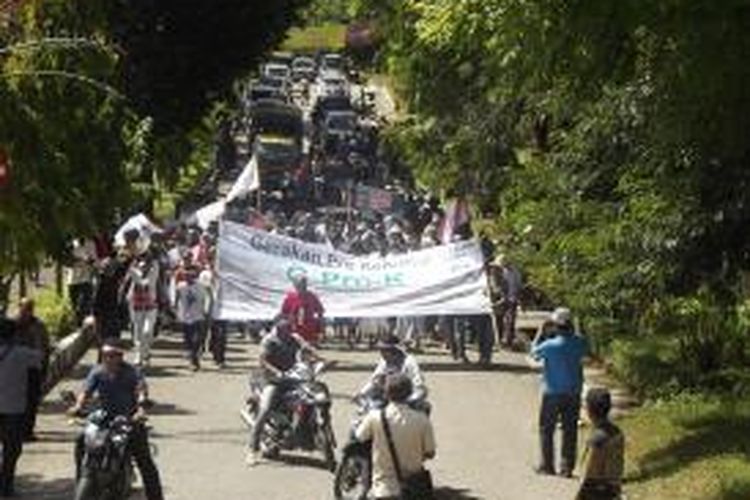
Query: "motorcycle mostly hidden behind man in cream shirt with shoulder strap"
333 390 432 500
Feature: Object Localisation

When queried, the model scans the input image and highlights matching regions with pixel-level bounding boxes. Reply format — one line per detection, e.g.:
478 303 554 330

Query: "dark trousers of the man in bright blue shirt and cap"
539 393 581 472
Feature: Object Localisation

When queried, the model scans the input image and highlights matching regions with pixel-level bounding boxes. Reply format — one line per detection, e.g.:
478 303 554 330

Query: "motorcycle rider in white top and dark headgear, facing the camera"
356 335 427 403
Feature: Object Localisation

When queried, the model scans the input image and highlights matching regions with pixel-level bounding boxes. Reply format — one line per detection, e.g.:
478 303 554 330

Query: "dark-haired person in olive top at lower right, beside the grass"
576 388 625 500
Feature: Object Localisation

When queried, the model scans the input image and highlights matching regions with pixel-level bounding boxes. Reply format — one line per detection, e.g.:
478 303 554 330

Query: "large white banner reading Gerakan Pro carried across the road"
214 222 490 321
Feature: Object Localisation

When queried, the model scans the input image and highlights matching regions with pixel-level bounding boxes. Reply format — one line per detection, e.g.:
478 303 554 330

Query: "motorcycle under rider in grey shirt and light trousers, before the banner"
240 362 336 472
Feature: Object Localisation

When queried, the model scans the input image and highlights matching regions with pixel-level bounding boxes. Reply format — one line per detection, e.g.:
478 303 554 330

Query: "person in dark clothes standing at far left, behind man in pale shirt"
16 298 51 441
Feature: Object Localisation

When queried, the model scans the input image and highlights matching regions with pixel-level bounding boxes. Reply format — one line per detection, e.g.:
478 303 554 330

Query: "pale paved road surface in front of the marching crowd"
19 335 575 500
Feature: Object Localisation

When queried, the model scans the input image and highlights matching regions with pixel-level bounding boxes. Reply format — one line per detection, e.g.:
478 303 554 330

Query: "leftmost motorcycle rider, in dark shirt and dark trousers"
68 338 164 500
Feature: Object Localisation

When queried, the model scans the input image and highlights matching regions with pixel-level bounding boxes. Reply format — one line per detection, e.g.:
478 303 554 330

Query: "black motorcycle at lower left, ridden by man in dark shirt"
74 410 134 500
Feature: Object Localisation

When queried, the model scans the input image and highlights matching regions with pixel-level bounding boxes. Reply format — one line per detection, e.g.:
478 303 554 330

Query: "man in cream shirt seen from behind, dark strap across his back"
355 374 435 500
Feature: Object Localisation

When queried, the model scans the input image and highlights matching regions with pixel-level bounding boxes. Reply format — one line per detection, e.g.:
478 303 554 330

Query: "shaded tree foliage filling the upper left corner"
0 0 307 296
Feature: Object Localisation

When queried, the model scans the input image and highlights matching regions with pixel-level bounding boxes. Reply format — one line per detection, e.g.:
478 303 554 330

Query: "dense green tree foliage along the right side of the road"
368 0 750 390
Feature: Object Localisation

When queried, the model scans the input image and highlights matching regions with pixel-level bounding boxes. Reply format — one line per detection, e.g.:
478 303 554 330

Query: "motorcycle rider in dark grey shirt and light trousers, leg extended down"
245 315 324 467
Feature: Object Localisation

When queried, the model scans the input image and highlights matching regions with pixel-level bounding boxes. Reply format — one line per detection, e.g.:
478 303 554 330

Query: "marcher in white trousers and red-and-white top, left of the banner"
126 255 159 366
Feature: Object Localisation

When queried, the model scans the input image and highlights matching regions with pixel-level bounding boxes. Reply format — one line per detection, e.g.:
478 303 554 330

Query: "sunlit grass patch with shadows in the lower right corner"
621 396 750 500
